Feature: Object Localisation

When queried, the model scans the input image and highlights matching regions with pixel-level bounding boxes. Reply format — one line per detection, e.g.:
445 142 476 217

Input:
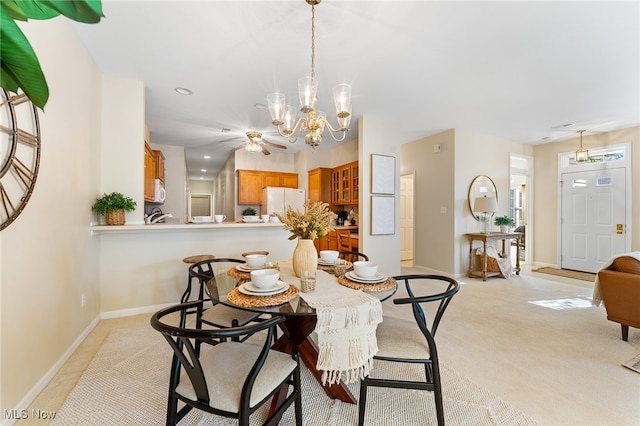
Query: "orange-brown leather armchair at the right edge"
596 253 640 342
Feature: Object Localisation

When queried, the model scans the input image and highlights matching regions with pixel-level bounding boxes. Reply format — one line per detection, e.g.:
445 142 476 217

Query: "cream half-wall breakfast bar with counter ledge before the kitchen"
91 222 297 312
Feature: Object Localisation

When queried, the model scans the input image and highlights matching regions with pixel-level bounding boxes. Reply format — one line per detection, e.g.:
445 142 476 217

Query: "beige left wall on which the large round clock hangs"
0 18 102 410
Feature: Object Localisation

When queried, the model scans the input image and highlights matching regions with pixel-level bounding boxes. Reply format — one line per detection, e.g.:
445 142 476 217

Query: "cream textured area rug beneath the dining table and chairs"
52 327 537 426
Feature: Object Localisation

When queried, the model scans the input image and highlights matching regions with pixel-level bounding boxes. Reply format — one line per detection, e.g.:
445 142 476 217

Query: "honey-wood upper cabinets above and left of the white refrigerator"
238 170 298 205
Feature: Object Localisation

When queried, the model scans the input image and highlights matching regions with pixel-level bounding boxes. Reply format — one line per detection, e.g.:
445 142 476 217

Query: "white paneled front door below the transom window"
560 168 627 273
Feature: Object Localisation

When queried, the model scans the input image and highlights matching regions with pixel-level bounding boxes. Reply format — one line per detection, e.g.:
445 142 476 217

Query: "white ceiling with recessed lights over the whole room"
71 0 640 179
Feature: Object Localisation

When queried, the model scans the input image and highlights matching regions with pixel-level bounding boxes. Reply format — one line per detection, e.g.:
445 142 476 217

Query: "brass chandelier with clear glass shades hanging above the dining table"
267 0 351 148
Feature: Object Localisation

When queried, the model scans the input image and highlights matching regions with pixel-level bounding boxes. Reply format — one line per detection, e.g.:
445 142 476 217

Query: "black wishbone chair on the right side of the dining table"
358 274 460 426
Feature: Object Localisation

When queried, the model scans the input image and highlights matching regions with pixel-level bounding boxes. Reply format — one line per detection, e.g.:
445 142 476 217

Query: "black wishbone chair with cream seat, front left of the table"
151 301 302 426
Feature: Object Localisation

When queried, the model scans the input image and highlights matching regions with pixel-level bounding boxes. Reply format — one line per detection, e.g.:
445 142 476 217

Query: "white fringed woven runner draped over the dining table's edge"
278 261 382 384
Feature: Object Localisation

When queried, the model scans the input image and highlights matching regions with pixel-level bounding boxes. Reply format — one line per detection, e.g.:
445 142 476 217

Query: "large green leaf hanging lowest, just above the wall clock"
0 11 49 109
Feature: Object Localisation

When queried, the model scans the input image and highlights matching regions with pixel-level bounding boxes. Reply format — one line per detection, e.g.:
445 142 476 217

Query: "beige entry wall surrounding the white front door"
533 127 640 265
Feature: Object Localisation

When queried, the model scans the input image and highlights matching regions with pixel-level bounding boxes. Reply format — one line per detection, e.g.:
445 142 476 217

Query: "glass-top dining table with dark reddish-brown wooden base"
209 260 397 410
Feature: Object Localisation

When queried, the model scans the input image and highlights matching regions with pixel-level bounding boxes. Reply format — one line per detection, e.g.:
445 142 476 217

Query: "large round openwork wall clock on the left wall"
0 89 41 230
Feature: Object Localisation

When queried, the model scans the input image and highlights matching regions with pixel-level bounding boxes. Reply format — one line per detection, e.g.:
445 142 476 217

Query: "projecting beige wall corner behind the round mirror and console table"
400 129 532 276
